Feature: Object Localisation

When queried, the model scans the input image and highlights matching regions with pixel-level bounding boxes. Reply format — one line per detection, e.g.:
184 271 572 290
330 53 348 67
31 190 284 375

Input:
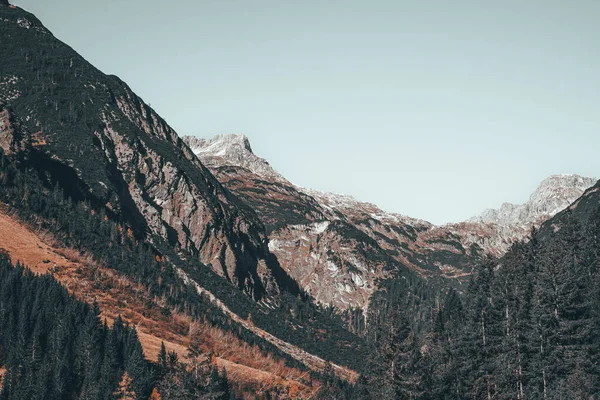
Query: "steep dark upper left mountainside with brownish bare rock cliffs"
0 7 278 299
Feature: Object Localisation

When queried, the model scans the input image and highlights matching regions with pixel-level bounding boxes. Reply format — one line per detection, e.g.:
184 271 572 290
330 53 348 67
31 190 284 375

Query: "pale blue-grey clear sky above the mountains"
13 0 600 223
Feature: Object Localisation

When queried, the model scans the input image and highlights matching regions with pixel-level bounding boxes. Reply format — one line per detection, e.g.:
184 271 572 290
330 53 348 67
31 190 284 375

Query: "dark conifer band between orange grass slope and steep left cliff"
0 150 362 369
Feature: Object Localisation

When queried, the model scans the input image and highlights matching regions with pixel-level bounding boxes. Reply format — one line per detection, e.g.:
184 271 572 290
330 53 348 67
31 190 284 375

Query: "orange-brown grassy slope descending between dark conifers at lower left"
0 205 320 399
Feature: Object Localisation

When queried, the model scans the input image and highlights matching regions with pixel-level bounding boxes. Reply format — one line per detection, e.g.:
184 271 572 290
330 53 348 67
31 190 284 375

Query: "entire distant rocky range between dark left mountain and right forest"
184 135 594 309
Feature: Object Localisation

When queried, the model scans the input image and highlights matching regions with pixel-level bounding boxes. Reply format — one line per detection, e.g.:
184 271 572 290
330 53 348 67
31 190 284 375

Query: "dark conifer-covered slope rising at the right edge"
398 180 600 399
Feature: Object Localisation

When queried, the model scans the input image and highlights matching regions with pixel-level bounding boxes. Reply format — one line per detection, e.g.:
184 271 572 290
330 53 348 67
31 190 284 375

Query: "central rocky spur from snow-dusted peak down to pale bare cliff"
184 135 393 308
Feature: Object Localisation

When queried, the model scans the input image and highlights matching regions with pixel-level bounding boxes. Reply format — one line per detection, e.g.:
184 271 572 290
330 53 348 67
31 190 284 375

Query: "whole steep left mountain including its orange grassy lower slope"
0 3 364 398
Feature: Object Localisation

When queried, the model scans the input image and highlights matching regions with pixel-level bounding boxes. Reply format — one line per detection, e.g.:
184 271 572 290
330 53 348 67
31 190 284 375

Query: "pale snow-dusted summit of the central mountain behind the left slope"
183 134 287 182
